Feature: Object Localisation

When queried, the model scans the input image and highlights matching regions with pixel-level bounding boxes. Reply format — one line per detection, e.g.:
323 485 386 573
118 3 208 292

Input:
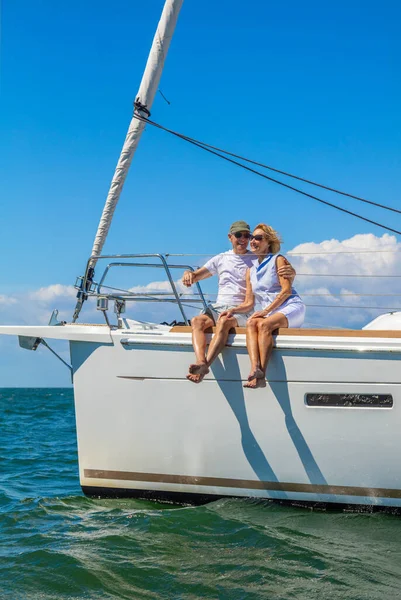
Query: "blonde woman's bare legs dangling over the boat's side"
244 313 288 389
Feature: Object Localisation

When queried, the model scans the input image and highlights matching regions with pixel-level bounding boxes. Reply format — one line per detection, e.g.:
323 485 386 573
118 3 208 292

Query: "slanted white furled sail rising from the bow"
92 0 183 265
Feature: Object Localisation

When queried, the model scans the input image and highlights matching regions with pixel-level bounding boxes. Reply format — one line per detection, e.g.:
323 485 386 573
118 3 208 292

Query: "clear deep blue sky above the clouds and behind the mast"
0 0 401 383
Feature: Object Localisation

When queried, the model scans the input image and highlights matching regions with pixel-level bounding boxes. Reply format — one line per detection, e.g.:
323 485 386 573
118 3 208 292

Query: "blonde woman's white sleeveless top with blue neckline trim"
250 254 302 310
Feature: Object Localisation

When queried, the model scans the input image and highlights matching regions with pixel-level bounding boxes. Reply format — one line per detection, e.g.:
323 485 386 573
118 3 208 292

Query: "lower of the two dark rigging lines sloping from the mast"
134 113 401 235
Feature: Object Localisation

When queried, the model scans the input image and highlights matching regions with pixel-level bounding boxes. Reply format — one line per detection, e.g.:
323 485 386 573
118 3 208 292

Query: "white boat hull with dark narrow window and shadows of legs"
70 330 401 506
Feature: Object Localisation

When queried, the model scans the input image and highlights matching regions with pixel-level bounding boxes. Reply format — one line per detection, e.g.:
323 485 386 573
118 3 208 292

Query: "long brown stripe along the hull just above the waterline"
84 469 401 498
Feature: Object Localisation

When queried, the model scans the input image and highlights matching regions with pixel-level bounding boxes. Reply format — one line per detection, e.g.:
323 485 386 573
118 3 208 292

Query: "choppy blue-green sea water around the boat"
0 389 401 600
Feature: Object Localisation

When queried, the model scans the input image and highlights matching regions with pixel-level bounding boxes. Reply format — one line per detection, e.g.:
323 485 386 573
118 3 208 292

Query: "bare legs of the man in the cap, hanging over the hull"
187 315 237 383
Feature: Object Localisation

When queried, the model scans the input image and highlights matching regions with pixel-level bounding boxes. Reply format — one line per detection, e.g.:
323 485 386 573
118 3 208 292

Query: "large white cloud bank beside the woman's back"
287 233 401 328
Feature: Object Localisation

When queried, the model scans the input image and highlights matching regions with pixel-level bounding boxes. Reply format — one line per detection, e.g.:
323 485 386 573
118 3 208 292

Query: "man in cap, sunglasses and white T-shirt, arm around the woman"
182 221 295 383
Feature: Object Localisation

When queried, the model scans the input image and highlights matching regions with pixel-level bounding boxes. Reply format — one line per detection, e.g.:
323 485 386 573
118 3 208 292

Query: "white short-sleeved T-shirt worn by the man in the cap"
204 250 257 306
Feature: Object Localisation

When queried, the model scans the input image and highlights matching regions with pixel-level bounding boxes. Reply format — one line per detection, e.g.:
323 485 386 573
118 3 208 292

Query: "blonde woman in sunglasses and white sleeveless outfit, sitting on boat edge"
219 223 305 389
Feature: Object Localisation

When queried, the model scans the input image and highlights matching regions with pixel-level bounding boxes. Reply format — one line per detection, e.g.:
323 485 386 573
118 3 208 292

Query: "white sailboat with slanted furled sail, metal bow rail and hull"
0 0 401 507
